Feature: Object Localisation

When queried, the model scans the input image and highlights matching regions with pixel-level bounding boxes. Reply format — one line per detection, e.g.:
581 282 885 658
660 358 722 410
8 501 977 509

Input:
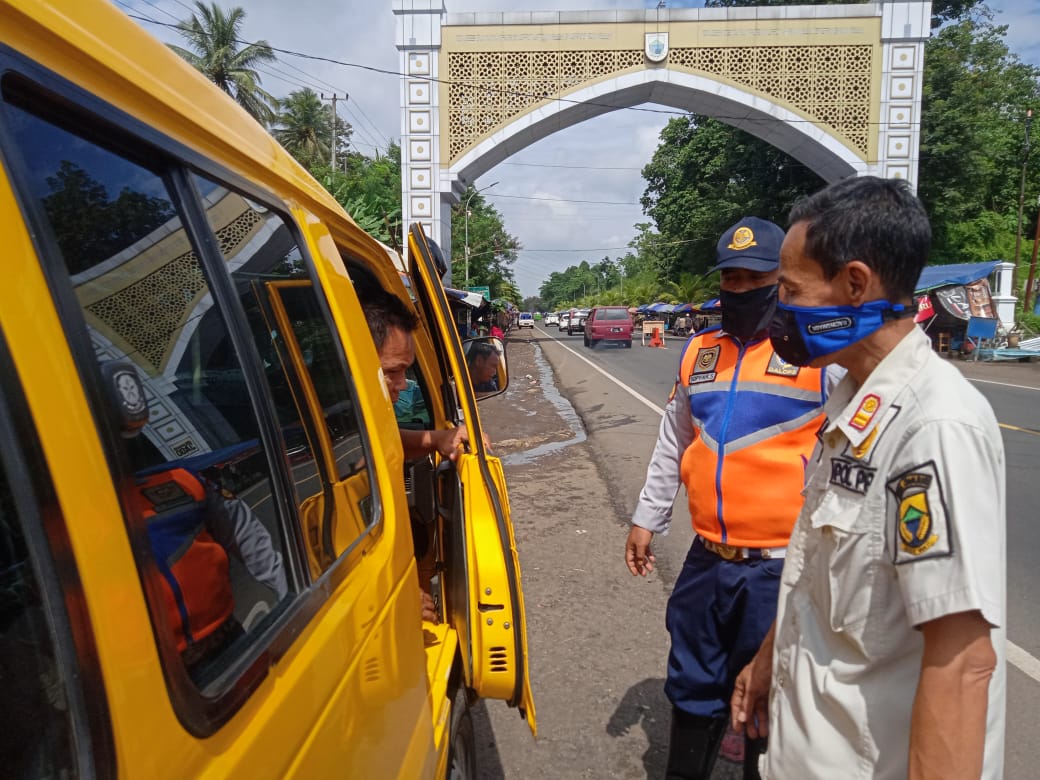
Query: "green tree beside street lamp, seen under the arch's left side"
451 187 521 304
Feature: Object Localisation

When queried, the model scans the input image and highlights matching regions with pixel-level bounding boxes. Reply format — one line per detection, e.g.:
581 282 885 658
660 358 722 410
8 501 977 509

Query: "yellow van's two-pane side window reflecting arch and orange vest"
4 91 374 698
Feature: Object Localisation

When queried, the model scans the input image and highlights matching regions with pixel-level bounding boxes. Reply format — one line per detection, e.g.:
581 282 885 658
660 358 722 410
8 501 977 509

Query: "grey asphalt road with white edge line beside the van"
478 327 1040 780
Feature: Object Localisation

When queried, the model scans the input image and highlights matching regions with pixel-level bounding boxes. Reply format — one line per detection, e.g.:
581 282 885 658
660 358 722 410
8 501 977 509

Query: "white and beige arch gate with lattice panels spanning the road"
393 0 931 266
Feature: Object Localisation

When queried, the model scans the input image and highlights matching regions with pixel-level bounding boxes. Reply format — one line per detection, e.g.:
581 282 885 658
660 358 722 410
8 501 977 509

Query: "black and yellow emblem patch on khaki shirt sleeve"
887 461 953 564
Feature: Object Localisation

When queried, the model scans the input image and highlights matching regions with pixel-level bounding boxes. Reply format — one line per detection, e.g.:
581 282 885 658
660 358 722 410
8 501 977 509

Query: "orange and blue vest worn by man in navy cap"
676 327 825 547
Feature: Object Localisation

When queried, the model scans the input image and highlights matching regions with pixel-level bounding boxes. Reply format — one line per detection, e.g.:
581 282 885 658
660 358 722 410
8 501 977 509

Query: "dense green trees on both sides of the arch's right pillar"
634 0 1040 281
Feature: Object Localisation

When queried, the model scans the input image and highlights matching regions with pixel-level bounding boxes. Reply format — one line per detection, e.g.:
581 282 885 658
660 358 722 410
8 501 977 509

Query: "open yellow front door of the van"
409 225 537 733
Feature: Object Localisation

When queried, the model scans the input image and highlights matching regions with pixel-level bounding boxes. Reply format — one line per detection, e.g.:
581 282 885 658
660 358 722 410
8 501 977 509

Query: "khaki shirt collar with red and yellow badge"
824 328 932 447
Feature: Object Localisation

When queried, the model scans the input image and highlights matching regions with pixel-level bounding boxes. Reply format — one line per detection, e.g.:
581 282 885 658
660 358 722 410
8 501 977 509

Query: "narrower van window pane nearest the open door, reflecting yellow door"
192 175 375 577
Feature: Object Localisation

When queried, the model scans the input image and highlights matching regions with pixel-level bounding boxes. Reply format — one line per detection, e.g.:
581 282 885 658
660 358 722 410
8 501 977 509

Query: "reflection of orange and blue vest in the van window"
133 468 234 652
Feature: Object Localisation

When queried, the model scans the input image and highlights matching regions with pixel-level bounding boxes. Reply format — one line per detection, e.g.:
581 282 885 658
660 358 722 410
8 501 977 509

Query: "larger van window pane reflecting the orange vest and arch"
7 100 301 690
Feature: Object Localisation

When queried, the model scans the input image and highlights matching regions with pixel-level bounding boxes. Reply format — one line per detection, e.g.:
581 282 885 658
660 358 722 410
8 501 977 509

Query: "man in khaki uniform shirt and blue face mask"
732 177 1006 779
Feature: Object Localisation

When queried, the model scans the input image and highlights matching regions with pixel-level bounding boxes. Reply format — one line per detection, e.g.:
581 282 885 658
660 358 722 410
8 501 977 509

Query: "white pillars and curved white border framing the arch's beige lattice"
393 0 931 272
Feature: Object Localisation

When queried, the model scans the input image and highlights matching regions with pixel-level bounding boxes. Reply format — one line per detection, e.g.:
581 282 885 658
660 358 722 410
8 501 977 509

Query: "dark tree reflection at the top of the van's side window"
44 160 175 274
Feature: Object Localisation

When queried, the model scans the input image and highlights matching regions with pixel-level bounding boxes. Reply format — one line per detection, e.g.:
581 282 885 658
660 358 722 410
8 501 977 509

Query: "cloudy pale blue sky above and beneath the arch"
123 0 1040 296
